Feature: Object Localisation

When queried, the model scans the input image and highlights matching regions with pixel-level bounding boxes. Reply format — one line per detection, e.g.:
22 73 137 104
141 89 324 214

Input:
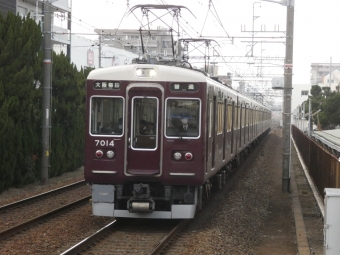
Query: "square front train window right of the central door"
165 99 200 137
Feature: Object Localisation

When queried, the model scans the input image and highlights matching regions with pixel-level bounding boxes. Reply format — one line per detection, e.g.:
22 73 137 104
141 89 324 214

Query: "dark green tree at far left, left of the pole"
0 12 42 191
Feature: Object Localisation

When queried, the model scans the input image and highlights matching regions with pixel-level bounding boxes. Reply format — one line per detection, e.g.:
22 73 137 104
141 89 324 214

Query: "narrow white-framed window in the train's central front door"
132 97 158 150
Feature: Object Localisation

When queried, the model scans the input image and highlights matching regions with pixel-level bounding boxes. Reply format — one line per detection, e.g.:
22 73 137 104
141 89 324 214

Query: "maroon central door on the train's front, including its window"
125 84 163 175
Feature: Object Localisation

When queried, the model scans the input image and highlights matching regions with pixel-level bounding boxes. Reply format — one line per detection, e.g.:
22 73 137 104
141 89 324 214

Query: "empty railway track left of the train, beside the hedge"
0 181 91 239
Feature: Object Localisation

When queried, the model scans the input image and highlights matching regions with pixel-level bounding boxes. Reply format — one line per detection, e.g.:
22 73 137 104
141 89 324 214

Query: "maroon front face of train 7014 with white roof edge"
85 64 206 219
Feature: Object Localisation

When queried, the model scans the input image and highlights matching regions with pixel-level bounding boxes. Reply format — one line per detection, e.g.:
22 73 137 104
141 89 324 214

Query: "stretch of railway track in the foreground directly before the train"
62 219 189 255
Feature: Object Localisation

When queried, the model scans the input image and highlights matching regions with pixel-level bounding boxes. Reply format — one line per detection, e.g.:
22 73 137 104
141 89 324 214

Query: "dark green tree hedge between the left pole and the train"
50 53 86 176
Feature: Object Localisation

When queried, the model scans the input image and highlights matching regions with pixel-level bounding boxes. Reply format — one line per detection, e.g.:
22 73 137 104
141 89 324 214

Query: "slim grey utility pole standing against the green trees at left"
41 1 52 185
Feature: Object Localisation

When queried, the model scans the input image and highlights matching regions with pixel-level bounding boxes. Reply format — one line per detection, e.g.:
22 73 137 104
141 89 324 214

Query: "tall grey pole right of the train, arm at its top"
261 0 295 193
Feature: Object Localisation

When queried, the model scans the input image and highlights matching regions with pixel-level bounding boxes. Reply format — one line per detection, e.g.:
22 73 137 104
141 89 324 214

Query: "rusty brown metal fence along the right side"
292 125 340 198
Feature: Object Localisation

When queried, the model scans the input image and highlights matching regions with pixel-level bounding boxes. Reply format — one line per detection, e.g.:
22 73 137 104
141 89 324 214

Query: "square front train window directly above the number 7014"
91 97 124 136
